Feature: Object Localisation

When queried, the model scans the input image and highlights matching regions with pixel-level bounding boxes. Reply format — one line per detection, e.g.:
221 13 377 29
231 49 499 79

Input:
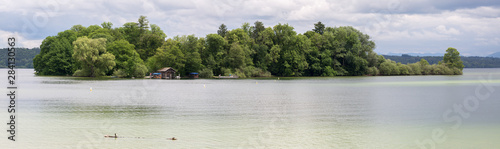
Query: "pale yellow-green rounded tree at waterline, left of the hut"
73 37 116 77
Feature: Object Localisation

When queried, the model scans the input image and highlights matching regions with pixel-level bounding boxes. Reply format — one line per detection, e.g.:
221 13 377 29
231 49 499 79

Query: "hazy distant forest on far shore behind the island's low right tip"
383 54 500 68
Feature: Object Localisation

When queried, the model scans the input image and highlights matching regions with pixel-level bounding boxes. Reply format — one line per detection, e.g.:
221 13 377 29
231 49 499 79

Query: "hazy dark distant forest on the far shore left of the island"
0 48 40 68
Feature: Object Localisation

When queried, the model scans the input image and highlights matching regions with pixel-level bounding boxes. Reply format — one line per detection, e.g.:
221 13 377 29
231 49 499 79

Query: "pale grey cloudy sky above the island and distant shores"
0 0 500 56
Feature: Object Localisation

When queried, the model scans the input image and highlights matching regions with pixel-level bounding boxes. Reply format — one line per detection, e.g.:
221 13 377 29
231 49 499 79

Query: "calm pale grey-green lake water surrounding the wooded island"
0 69 500 148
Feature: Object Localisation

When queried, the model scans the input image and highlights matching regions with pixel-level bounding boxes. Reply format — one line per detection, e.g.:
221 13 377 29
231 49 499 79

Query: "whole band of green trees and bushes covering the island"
33 16 464 78
